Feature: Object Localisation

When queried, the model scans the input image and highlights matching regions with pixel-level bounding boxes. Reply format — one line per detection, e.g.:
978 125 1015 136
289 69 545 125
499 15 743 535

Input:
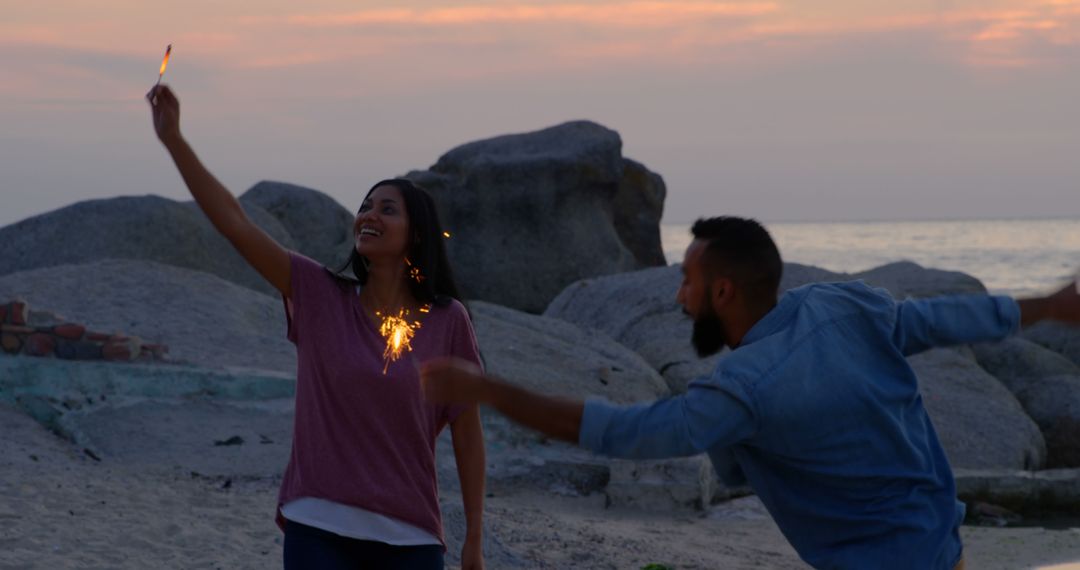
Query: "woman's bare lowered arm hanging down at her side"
450 406 487 570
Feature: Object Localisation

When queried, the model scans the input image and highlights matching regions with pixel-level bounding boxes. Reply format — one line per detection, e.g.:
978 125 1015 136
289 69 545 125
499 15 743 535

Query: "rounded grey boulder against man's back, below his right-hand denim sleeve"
908 349 1047 470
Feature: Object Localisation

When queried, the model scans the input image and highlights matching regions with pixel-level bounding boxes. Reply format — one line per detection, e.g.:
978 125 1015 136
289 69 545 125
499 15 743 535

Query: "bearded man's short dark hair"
690 216 784 301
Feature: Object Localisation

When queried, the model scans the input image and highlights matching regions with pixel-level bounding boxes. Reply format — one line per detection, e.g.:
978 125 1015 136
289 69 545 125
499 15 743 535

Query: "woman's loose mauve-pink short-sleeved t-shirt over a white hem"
278 253 480 545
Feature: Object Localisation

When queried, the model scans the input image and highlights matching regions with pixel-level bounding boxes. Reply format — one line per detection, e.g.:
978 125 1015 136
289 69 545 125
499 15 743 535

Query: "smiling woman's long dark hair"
338 178 462 306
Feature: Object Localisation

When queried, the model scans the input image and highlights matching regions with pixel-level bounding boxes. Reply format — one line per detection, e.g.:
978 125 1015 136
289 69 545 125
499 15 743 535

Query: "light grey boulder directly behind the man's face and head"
544 263 845 393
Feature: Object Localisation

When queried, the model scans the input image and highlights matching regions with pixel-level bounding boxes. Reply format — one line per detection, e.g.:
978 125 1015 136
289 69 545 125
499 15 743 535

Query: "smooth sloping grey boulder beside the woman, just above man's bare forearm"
469 301 667 404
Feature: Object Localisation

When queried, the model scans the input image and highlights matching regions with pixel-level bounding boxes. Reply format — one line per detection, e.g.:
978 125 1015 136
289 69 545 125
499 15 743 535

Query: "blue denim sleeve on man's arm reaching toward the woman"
578 383 755 459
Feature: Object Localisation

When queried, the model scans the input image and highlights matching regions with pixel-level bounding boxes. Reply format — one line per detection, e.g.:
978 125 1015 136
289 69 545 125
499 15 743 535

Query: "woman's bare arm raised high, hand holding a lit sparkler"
147 85 289 297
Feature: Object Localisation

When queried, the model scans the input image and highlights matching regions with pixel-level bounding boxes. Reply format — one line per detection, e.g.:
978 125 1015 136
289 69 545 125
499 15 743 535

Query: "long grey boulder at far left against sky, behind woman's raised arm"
0 195 295 294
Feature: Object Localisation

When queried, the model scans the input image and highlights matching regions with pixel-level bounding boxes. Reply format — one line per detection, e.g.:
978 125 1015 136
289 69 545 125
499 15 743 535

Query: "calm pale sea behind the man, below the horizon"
661 220 1080 296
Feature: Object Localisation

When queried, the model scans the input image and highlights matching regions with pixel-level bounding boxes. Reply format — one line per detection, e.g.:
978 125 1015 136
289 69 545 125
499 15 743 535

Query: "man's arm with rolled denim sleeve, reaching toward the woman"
421 359 754 459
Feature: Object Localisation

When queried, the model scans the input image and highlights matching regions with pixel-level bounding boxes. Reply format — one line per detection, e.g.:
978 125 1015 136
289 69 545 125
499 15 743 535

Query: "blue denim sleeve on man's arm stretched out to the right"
893 295 1020 356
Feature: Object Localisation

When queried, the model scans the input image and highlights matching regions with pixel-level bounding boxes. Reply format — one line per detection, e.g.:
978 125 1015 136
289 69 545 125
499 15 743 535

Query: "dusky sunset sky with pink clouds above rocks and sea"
0 0 1080 226
